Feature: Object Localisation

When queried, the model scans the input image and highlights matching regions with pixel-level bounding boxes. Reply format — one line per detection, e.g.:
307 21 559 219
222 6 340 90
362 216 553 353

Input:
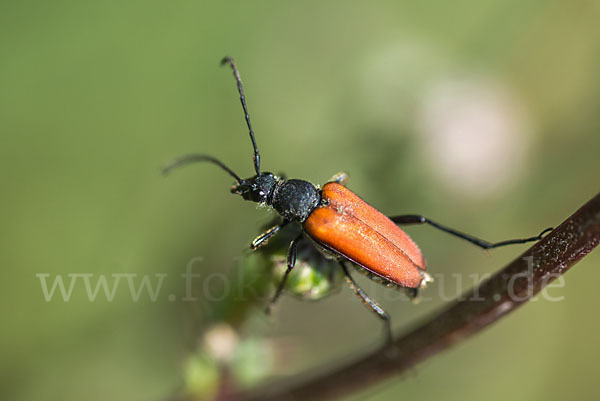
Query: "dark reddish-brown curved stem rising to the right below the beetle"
237 194 600 401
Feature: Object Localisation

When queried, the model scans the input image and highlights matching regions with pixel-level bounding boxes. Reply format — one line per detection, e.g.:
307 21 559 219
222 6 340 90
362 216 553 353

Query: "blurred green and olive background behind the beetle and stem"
0 0 600 401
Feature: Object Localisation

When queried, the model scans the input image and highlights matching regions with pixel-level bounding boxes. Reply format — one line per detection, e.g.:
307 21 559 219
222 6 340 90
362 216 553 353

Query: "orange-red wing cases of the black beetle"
304 182 425 288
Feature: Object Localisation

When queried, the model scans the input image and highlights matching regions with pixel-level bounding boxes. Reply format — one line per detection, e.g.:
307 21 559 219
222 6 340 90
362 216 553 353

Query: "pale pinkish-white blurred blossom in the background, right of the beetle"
418 79 530 197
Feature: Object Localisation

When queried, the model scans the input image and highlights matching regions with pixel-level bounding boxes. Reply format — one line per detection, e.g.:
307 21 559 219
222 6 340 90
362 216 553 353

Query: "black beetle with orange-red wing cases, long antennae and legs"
163 57 552 342
